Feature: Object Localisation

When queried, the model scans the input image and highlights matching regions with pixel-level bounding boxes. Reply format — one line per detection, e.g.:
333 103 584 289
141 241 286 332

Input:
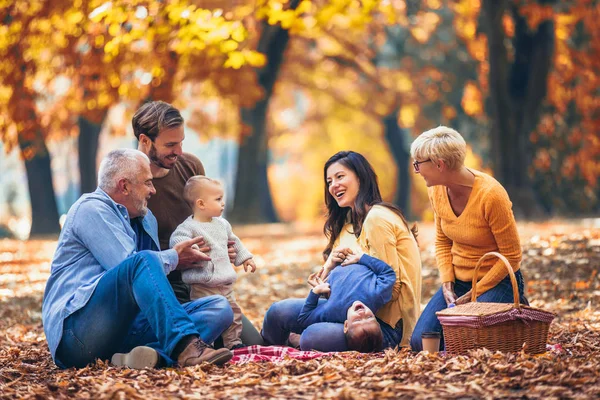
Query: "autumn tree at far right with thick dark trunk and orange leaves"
455 0 600 217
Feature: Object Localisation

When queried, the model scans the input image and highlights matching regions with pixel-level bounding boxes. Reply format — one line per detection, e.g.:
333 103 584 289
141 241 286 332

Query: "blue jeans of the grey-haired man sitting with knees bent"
56 251 233 368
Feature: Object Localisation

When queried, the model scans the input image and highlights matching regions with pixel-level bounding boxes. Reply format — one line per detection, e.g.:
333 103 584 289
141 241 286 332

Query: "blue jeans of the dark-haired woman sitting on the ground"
261 299 402 352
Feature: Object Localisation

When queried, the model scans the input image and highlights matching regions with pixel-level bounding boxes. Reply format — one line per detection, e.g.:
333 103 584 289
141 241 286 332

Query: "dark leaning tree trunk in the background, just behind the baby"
230 0 300 223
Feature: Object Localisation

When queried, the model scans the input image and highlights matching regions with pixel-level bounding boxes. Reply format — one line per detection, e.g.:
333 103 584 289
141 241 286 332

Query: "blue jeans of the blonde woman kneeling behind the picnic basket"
410 270 529 351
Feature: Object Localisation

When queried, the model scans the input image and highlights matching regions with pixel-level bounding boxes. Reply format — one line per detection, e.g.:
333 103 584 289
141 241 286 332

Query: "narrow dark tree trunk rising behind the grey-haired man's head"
77 116 102 194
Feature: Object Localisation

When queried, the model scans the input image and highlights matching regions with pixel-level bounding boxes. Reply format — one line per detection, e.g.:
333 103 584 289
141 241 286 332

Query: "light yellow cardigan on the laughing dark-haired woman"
334 206 421 346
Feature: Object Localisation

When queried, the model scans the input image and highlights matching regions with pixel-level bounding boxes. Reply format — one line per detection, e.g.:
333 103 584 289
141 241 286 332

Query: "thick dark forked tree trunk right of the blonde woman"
483 0 554 218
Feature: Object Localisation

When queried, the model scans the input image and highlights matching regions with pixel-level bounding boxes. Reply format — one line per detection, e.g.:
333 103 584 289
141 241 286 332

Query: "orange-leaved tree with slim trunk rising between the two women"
264 2 481 219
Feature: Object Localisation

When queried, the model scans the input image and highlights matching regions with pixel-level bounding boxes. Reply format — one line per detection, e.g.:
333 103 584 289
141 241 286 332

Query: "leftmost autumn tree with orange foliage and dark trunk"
0 1 73 236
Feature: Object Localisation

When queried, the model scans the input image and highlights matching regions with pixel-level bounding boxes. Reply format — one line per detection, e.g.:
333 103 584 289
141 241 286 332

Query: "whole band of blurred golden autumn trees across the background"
0 0 600 235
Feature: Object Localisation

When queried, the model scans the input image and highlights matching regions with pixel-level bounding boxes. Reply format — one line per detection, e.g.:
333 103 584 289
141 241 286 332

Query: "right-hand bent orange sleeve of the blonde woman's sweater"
477 188 522 295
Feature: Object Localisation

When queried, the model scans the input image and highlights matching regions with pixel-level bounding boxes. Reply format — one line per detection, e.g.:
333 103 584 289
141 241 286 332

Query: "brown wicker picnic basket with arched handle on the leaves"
436 252 555 354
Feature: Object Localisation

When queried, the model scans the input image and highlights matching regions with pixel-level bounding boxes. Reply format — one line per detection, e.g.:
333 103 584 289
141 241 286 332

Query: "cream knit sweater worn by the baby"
169 216 252 287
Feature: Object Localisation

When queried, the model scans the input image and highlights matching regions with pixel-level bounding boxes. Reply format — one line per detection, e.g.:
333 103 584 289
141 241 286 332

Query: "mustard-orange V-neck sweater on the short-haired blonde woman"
429 170 521 294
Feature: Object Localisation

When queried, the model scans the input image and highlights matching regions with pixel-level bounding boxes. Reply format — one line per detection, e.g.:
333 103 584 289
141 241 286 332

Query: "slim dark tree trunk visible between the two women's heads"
382 110 411 218
